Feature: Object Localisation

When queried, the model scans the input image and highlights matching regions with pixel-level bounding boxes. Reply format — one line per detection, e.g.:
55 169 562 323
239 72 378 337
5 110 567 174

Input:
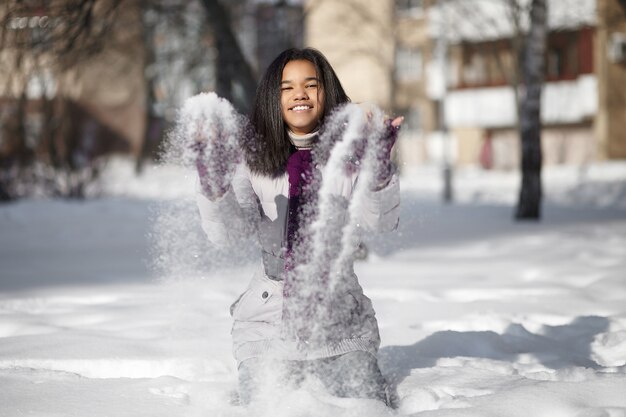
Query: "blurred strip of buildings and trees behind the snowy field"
0 0 626 213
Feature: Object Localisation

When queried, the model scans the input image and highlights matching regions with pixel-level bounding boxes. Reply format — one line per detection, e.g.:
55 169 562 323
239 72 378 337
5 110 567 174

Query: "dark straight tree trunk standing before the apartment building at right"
515 0 548 220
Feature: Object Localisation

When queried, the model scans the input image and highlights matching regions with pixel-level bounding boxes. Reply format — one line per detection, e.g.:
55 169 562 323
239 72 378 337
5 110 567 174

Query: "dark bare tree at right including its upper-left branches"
434 0 564 220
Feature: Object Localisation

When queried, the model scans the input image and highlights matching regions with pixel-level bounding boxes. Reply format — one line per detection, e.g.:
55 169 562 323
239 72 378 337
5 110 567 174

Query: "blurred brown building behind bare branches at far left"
0 1 146 160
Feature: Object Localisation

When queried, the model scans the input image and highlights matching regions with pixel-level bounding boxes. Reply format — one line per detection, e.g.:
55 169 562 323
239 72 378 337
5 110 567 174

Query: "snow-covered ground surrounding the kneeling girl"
0 161 626 417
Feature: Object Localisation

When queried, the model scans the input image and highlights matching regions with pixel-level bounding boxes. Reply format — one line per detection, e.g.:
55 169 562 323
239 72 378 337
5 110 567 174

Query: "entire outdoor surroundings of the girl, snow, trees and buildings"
0 4 626 417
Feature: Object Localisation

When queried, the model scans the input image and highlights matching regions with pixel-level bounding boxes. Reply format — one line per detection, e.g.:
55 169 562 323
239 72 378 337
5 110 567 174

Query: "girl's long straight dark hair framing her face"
244 48 350 177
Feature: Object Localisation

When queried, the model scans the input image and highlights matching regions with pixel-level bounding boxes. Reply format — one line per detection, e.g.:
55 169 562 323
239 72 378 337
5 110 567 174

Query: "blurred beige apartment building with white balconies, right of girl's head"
305 0 626 168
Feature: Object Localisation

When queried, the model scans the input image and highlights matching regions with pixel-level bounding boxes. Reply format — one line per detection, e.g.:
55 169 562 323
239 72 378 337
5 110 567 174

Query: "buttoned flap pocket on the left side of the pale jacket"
231 274 283 323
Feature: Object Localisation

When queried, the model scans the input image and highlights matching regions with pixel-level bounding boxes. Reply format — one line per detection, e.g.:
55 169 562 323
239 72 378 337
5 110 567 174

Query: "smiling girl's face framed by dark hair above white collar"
280 60 324 134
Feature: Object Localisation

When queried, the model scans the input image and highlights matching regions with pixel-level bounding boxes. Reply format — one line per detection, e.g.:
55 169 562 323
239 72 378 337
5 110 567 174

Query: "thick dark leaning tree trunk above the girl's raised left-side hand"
202 0 256 113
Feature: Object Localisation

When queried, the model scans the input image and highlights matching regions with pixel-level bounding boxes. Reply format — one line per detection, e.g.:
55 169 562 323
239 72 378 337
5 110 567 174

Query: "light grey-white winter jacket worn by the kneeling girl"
197 164 400 363
